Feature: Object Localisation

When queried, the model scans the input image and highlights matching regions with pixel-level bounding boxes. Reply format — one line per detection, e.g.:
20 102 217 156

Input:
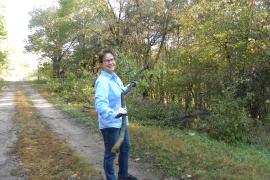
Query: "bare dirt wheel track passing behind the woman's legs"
23 85 160 180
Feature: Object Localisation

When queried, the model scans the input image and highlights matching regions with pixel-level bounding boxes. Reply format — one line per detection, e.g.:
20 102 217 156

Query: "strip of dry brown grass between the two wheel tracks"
16 91 102 180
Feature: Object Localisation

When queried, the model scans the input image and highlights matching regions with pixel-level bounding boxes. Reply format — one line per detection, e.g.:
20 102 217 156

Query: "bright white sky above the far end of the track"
4 0 57 81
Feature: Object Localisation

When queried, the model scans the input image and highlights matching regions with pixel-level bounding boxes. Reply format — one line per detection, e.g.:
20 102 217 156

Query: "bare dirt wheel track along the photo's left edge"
0 84 23 180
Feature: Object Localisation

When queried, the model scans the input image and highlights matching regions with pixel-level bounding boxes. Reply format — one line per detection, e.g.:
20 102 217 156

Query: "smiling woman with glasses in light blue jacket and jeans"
95 49 137 180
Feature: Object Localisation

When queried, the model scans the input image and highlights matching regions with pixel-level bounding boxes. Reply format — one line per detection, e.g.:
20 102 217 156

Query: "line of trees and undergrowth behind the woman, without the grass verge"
26 0 270 142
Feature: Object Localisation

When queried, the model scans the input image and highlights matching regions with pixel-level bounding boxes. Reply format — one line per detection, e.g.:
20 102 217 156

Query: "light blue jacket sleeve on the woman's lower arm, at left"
95 80 115 121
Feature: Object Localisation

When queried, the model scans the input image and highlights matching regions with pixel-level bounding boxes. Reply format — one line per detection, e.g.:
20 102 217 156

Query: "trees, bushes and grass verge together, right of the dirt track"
25 0 270 179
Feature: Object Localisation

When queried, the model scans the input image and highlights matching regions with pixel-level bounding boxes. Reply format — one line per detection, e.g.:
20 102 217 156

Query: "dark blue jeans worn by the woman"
101 127 130 180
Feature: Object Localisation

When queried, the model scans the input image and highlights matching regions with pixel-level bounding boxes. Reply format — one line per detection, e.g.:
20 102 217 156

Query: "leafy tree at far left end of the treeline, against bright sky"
26 7 77 78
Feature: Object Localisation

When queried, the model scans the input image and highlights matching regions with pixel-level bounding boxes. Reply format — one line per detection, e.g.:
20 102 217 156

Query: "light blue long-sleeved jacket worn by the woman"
95 71 128 129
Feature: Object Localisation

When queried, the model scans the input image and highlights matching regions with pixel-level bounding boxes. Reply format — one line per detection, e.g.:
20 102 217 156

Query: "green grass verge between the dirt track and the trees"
29 81 270 180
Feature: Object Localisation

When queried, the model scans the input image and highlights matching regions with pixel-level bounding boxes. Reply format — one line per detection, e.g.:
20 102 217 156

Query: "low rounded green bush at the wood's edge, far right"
209 95 252 143
